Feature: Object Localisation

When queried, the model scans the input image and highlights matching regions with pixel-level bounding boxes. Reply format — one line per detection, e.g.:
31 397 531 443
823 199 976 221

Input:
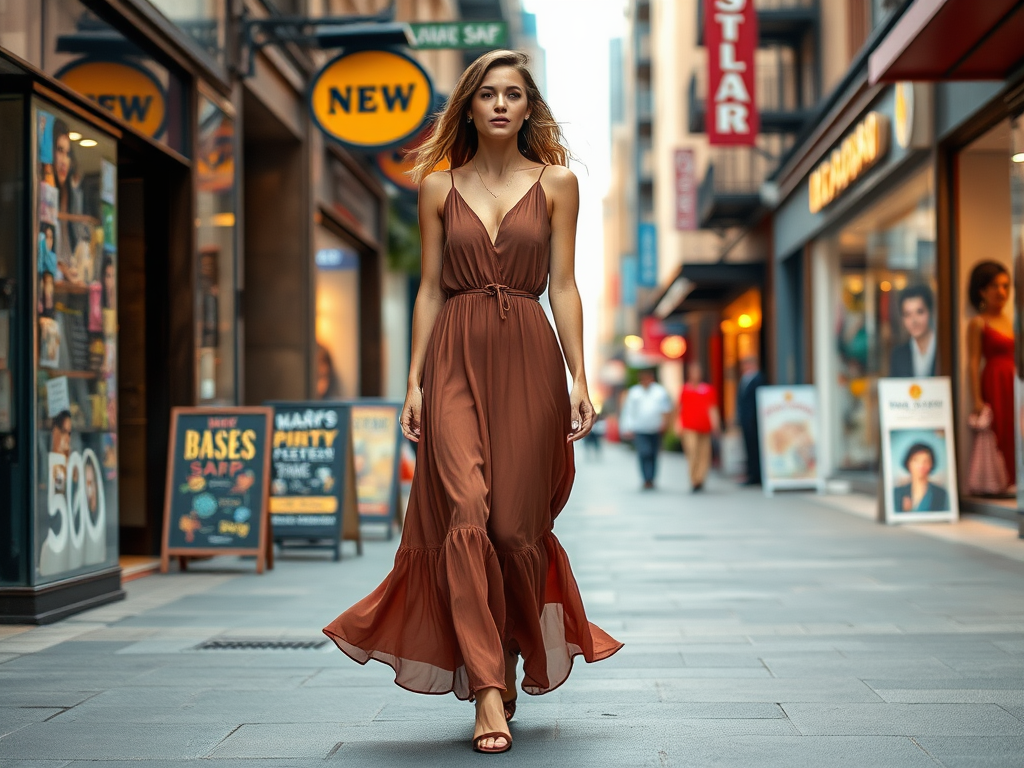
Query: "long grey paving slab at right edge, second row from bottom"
782 703 1024 736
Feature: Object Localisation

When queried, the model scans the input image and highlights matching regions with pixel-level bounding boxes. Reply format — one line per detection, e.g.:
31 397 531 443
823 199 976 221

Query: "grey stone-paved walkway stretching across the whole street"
0 446 1024 768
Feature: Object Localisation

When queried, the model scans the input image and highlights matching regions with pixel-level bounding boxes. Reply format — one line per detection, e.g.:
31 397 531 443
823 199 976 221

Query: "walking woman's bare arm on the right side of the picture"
544 166 594 440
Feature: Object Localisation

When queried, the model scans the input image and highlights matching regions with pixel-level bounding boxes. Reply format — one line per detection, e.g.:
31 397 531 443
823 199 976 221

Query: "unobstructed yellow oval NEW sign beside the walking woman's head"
309 50 434 150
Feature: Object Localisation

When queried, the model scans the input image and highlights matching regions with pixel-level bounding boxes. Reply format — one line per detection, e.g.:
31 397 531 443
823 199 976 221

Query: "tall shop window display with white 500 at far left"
30 99 118 584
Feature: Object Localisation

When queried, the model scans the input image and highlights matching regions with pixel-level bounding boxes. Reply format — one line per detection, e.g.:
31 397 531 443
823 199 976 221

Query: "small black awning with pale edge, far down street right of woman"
647 262 765 319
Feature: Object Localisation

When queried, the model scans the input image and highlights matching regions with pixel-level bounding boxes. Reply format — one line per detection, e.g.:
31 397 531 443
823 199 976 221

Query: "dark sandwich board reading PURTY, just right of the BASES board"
266 401 362 561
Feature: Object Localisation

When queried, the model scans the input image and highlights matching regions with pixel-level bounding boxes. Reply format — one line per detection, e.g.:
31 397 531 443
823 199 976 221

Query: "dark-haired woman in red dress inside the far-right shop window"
967 261 1017 482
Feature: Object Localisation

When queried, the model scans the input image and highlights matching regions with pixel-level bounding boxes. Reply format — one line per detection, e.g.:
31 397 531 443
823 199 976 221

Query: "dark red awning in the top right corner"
867 0 1024 84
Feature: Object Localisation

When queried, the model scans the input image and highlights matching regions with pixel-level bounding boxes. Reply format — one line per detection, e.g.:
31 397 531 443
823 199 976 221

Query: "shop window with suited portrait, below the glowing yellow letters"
814 168 937 472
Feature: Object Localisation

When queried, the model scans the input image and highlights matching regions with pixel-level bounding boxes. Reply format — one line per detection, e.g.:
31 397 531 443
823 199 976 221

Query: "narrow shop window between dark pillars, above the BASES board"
196 96 238 403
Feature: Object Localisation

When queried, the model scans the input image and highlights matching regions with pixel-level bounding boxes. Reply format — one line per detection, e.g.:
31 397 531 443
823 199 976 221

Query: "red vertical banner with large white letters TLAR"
701 0 761 146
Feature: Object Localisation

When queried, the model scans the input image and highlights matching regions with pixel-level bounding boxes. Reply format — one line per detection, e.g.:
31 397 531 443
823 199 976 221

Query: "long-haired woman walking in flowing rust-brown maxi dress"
325 51 622 753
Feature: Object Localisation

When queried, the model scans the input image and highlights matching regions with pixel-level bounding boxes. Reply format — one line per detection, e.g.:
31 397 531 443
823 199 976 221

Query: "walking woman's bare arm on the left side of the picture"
401 173 452 442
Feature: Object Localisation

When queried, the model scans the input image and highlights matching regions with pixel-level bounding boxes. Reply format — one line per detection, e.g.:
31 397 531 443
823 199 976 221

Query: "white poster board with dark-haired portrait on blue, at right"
879 376 959 524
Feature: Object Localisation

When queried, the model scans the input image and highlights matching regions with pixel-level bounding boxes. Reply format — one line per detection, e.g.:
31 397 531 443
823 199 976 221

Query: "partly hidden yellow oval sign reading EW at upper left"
57 58 167 138
